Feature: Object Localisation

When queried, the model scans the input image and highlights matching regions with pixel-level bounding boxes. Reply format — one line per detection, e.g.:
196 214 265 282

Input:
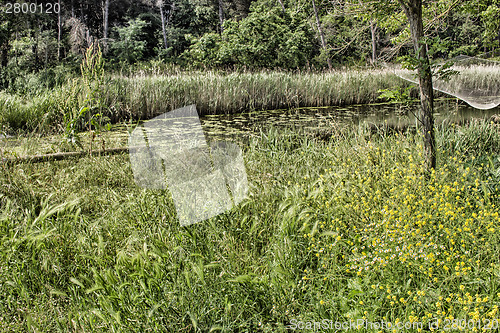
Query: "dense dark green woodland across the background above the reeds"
0 0 500 94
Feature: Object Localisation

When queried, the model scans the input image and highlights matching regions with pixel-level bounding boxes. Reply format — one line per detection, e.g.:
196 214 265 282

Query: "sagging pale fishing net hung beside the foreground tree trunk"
395 56 500 110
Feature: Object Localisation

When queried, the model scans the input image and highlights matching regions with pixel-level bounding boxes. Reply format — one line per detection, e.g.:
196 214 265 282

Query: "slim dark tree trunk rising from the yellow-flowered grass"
399 0 436 171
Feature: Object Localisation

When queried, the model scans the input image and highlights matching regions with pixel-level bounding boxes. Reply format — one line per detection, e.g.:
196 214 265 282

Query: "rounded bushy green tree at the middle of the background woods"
186 3 318 68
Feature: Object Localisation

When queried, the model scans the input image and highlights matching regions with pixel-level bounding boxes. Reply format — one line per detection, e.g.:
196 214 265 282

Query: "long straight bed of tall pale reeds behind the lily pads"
106 71 402 119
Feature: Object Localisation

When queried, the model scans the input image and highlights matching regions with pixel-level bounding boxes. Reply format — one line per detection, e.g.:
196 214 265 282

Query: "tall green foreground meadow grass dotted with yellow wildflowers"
0 122 500 332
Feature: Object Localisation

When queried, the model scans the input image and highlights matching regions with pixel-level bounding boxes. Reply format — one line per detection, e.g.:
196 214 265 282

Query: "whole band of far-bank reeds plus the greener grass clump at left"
0 70 416 132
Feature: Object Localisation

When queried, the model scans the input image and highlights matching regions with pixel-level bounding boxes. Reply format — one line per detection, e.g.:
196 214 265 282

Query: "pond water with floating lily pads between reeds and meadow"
0 99 500 156
